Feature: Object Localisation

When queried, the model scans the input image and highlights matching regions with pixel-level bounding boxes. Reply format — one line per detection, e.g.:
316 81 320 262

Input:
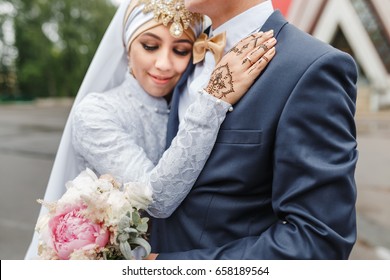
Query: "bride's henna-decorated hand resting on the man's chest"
205 30 276 105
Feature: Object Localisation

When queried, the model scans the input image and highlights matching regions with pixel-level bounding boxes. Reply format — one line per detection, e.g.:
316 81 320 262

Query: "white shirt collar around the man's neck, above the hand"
211 0 274 53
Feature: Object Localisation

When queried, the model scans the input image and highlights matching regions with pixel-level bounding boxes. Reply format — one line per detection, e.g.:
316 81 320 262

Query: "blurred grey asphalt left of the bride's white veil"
0 99 69 259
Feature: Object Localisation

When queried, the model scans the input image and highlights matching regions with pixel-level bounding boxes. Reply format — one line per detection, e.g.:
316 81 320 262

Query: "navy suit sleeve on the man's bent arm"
159 51 358 259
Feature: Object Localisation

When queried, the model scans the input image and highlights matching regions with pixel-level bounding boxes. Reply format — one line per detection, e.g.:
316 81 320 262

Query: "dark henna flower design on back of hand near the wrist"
206 63 234 98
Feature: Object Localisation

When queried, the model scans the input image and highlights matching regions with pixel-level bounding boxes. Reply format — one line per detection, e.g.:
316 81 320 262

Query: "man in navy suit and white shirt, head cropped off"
151 0 357 259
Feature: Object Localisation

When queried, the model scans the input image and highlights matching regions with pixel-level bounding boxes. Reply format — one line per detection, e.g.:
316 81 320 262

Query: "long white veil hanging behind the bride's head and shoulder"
25 0 202 259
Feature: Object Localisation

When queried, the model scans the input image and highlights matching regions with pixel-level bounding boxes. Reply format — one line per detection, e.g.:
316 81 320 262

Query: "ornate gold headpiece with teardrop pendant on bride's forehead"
139 0 202 38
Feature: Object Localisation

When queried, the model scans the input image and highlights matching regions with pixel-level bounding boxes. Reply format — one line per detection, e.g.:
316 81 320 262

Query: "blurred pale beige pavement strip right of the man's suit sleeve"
351 113 390 260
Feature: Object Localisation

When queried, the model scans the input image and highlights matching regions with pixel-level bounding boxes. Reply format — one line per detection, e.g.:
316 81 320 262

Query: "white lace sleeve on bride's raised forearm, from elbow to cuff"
144 94 230 218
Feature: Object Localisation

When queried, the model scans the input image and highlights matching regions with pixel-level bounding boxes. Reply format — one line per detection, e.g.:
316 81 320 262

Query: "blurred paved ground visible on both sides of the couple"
0 101 390 260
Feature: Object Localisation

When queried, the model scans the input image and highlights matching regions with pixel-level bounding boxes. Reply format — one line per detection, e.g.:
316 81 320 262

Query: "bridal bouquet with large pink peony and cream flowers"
35 169 152 260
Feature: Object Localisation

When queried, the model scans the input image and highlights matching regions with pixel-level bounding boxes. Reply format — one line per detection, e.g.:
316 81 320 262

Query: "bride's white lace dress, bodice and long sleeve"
72 74 231 218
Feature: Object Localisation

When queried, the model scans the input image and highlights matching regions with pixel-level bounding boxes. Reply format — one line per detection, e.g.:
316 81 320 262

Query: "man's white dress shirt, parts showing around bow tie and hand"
179 0 274 122
